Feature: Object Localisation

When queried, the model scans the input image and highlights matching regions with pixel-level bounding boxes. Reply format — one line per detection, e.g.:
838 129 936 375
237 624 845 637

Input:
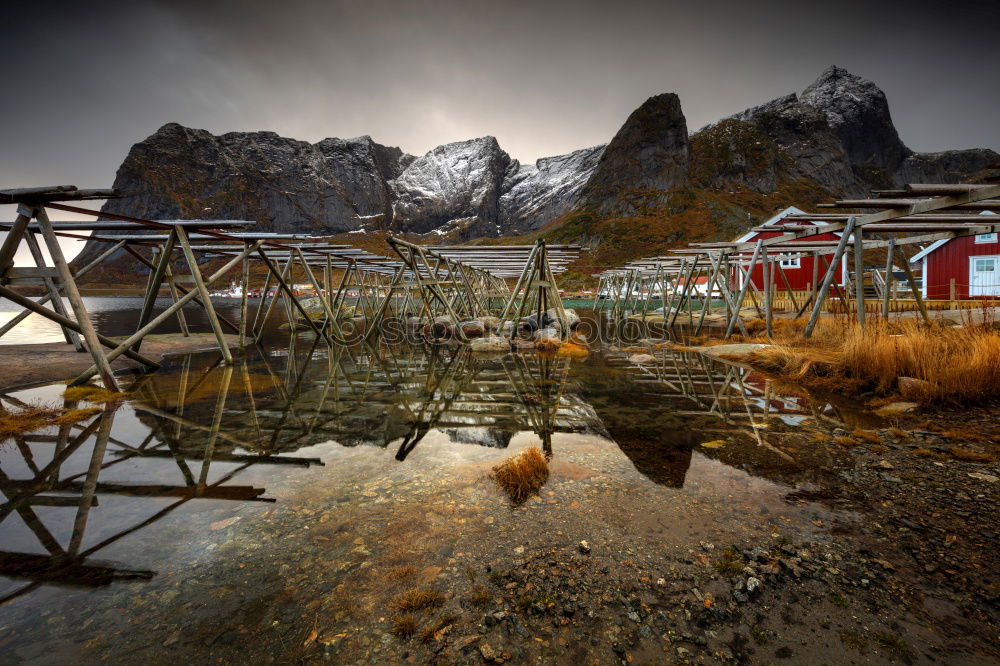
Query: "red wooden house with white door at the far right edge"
910 211 1000 300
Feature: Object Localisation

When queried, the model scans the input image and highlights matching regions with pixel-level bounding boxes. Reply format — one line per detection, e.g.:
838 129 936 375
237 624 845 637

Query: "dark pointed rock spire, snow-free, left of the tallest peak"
580 93 691 215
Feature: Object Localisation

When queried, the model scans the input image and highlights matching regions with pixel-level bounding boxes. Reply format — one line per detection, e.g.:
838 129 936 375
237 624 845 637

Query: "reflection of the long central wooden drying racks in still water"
133 336 593 464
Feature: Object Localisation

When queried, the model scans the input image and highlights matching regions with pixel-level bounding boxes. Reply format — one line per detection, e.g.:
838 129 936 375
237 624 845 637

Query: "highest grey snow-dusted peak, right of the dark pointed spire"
692 66 1000 196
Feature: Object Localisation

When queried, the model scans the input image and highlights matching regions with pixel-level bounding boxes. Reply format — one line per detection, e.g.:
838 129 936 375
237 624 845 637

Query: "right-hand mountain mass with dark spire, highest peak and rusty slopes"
546 67 1000 273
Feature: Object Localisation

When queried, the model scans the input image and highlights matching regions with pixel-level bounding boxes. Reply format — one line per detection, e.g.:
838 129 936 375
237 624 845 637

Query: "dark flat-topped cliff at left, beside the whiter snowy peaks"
103 123 407 233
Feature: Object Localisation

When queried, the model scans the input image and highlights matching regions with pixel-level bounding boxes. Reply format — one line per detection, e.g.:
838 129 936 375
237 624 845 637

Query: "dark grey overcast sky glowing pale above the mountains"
0 0 1000 195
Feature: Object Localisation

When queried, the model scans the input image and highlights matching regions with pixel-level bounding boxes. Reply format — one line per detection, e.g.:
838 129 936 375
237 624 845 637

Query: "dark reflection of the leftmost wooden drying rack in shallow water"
0 376 322 604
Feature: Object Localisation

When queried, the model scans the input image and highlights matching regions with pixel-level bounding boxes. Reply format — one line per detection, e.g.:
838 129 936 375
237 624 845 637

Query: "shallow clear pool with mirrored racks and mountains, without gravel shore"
0 308 868 663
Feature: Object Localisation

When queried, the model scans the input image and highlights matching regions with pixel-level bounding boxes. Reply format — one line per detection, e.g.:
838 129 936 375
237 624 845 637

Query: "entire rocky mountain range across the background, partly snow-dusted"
83 67 1000 276
